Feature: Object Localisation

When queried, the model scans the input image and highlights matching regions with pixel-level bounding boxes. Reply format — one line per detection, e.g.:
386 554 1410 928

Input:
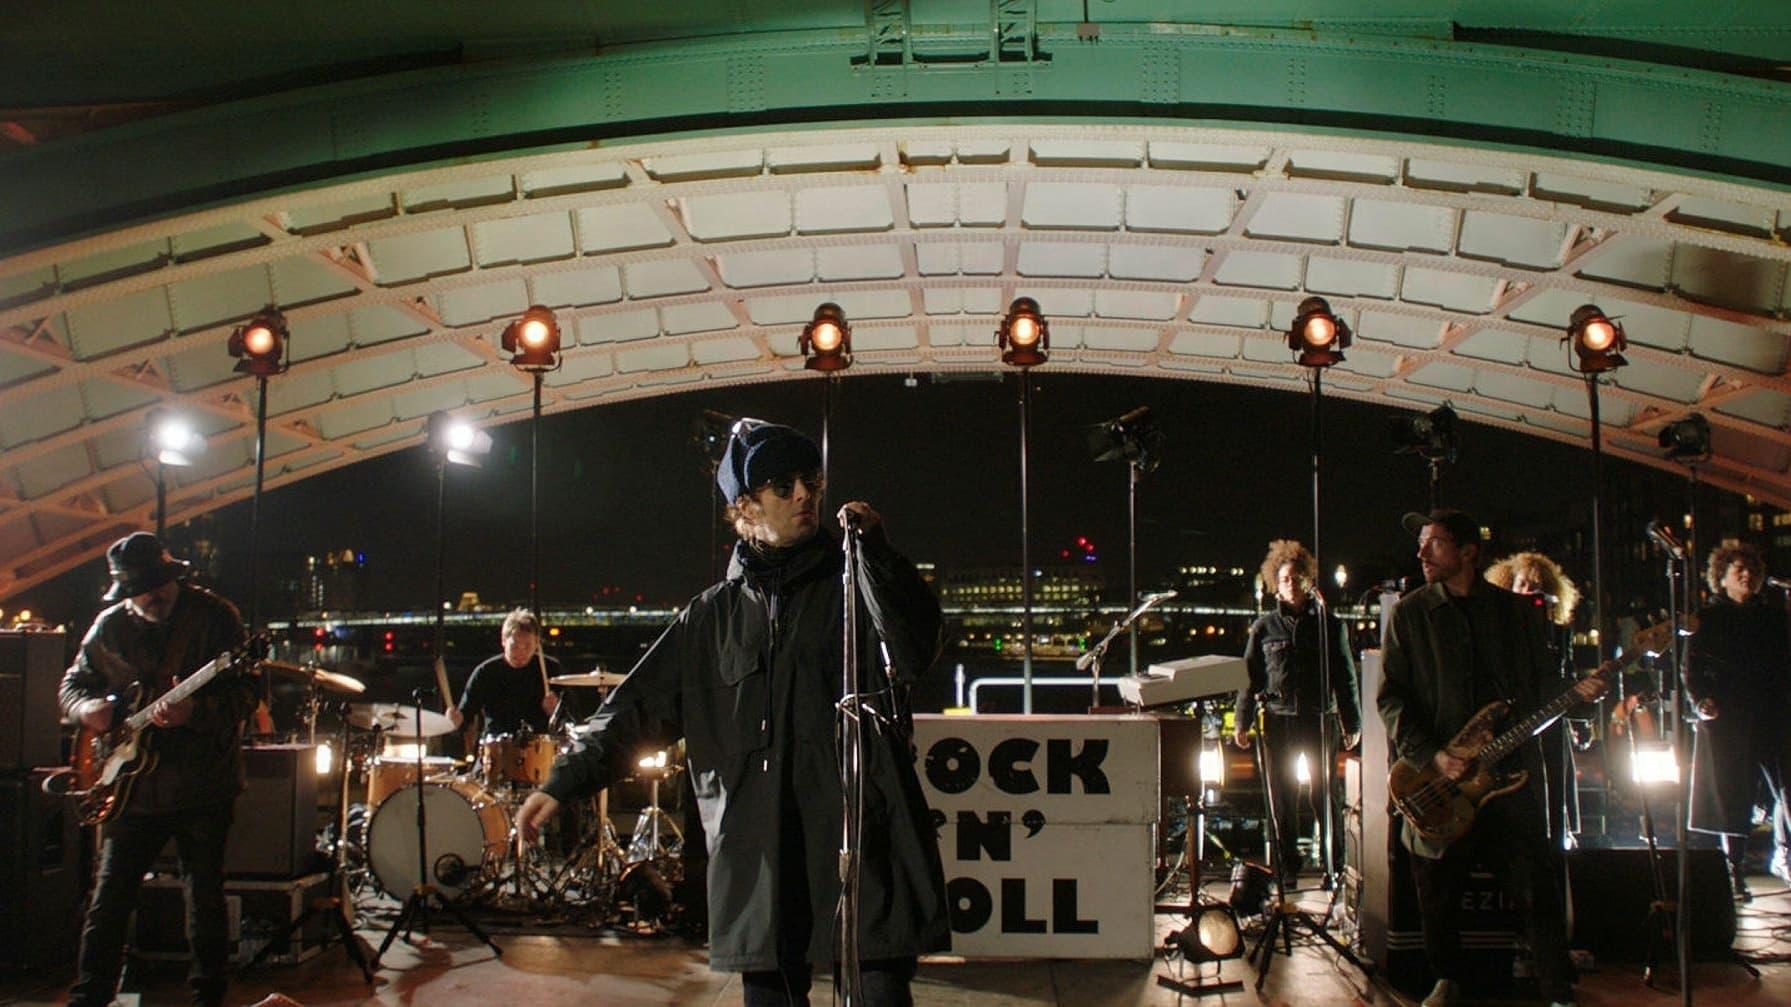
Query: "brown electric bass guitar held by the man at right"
1386 624 1671 846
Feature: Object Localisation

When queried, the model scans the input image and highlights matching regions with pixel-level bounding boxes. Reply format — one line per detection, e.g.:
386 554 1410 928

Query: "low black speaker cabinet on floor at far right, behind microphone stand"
1567 838 1735 962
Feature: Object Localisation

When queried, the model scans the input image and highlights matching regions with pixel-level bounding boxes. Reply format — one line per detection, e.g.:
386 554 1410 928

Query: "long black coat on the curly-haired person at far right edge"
1685 597 1791 835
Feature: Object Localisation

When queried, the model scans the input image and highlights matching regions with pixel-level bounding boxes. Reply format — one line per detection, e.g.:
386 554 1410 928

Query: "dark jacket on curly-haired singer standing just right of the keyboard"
1238 598 1361 735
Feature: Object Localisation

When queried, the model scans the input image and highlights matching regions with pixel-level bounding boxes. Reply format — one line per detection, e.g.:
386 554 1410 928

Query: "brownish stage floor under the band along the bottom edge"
13 876 1791 1007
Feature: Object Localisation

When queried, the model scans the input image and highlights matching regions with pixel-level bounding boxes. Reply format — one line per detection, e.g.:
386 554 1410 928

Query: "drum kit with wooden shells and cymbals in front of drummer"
263 661 682 930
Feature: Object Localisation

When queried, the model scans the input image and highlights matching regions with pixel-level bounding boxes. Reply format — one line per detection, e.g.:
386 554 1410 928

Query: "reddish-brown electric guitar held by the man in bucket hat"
64 636 267 826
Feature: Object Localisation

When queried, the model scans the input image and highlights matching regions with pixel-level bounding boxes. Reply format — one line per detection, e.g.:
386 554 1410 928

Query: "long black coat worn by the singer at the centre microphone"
543 530 949 971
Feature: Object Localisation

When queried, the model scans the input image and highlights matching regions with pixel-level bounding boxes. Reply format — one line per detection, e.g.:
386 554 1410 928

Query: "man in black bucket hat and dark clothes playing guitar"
61 532 258 1007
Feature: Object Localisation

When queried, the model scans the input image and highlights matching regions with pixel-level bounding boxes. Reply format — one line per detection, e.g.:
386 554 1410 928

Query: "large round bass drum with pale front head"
367 779 510 899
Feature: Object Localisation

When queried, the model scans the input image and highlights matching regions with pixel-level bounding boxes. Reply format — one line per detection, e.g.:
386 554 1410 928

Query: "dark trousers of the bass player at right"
1411 787 1572 1000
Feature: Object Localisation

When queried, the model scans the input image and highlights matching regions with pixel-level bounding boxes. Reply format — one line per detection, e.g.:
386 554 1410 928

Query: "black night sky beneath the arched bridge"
7 374 1712 631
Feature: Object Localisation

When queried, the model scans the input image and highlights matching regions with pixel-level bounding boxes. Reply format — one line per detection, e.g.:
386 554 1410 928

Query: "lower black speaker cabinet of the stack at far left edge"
0 770 81 968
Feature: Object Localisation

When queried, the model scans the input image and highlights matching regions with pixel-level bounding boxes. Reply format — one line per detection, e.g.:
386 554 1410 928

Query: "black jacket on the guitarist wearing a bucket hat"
59 582 260 815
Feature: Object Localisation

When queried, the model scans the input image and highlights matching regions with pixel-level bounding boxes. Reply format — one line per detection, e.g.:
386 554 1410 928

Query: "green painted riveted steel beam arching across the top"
0 23 1791 253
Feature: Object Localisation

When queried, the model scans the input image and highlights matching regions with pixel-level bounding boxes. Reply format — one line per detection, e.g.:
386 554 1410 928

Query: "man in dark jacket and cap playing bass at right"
1377 509 1599 1007
